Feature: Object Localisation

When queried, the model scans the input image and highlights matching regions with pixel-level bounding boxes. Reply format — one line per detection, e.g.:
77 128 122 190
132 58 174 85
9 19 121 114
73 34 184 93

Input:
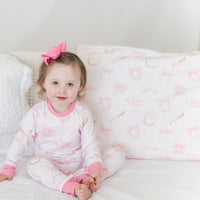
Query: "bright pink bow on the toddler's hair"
42 42 67 65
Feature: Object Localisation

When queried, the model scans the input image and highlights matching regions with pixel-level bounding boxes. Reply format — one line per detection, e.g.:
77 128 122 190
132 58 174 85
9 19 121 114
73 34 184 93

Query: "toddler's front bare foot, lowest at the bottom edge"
75 183 92 200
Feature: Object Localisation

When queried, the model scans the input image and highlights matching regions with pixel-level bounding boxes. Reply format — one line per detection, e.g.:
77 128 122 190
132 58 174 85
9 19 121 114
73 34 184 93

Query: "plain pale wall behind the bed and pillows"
0 0 200 52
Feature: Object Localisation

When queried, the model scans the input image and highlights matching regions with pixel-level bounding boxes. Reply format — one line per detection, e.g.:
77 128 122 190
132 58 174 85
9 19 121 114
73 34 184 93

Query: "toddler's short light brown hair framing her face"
36 52 87 100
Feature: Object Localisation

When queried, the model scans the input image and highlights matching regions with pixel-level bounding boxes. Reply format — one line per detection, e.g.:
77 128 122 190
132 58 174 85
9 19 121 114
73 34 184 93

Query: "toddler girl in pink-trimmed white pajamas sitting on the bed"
0 43 125 200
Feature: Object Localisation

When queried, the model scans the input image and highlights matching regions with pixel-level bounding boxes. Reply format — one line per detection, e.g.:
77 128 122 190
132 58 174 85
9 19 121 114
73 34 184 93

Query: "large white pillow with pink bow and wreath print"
78 45 200 160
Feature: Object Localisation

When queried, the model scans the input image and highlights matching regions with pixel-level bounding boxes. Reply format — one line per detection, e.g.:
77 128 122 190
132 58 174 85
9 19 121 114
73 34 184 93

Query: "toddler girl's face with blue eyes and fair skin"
43 63 81 113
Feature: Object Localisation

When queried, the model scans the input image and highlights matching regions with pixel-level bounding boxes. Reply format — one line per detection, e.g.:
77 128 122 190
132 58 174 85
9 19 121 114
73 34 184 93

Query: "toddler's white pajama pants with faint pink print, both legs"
27 148 125 192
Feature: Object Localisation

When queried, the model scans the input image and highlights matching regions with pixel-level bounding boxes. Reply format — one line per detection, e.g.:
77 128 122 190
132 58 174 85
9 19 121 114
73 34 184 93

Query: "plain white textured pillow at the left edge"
0 54 32 155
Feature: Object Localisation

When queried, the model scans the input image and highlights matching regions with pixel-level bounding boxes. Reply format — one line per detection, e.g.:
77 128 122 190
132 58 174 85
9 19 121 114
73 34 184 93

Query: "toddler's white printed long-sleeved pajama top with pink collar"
4 99 102 174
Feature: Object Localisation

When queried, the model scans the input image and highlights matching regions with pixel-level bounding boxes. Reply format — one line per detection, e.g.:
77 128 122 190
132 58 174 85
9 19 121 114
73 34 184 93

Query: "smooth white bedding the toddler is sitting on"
0 157 200 200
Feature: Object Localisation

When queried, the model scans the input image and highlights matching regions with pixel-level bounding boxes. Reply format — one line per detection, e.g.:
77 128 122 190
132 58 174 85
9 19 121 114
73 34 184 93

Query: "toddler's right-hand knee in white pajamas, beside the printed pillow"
101 147 126 180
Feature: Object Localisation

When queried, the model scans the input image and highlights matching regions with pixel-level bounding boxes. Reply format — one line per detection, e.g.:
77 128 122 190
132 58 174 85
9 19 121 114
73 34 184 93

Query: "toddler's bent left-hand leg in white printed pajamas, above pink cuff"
28 157 72 192
